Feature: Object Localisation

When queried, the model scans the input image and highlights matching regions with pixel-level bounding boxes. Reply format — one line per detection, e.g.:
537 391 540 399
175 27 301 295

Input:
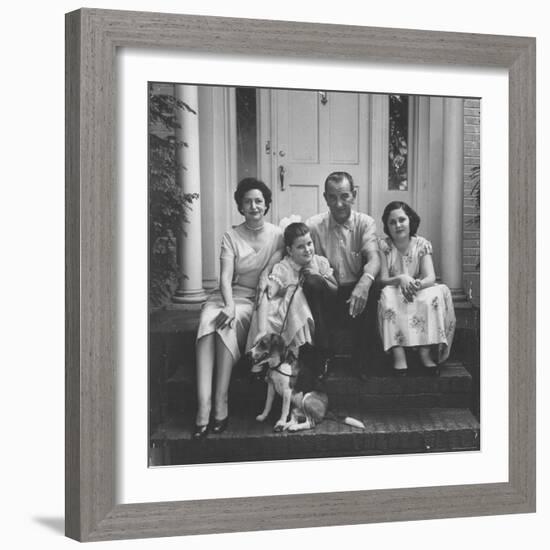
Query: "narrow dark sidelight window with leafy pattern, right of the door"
388 95 409 191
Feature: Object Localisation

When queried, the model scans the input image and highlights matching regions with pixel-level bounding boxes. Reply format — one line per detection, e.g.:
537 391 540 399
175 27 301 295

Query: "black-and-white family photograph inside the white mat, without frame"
147 82 482 467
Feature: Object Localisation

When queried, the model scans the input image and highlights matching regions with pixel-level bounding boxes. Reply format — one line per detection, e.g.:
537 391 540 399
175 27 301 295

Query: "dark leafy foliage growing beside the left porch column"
149 88 198 307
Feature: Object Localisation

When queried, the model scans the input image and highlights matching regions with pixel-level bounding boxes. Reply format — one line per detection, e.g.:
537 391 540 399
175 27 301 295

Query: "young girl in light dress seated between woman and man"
246 222 337 349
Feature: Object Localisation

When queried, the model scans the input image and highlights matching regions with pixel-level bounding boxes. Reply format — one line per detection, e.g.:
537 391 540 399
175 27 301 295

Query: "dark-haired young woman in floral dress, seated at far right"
378 201 456 375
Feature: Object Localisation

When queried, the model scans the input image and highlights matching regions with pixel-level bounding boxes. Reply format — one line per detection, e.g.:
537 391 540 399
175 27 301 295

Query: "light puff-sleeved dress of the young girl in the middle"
246 255 333 349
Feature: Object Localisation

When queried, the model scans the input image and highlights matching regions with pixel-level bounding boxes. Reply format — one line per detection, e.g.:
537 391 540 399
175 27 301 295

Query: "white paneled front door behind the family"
268 90 369 222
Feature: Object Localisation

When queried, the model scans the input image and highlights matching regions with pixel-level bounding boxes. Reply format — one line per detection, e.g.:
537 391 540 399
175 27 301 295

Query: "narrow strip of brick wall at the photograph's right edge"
462 99 480 305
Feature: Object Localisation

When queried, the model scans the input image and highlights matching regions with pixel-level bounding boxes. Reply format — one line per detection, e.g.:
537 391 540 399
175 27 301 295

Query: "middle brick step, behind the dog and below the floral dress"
166 362 473 414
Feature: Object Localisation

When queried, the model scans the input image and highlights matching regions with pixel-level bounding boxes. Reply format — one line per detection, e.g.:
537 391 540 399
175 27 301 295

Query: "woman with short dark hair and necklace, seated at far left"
193 178 283 439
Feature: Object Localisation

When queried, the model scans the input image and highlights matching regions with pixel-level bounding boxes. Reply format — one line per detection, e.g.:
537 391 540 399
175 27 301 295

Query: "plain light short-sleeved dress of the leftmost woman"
197 222 283 362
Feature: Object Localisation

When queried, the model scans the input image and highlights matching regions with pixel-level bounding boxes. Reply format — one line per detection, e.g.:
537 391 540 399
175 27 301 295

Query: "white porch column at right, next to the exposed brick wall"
441 98 466 301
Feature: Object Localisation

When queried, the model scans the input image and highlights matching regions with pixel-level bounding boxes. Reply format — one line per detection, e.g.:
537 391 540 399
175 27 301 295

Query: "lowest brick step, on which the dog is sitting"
149 408 480 466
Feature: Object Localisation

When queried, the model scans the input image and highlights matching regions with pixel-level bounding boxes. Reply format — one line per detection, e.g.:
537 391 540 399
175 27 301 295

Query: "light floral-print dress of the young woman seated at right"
378 236 456 363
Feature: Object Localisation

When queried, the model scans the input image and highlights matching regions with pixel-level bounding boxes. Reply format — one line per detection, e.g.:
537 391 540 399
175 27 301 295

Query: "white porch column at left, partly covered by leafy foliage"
173 85 206 304
